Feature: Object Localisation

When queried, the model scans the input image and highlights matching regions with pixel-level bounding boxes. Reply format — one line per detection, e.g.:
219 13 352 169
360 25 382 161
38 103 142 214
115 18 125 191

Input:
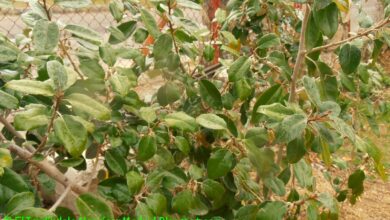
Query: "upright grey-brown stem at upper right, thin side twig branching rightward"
288 5 310 102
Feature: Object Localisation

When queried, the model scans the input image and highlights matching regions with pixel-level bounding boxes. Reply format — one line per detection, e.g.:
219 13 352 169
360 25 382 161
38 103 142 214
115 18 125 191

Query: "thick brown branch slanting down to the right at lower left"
8 143 87 194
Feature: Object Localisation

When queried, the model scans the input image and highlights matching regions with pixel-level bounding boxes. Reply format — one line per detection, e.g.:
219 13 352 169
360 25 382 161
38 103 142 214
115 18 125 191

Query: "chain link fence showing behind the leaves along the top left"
0 1 203 37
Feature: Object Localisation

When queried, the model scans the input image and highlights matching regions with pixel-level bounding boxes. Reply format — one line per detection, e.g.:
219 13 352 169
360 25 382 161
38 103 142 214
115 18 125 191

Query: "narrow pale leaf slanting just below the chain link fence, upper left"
64 24 102 45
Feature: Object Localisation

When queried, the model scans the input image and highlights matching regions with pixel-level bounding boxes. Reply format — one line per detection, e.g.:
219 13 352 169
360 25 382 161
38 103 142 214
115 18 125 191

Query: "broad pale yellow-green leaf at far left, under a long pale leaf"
14 104 49 131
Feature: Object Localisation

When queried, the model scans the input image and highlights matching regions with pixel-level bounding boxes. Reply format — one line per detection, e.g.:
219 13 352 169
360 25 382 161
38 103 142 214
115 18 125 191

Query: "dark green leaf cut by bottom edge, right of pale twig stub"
76 193 114 219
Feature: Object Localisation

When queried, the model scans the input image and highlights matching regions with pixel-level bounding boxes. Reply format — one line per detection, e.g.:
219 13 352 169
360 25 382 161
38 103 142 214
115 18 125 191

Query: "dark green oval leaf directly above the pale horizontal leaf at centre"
199 79 222 109
